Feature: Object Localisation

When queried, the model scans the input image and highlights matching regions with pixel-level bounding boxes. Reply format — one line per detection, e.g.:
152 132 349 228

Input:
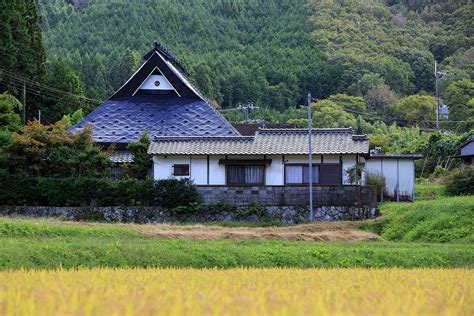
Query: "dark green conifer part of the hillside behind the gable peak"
40 0 339 109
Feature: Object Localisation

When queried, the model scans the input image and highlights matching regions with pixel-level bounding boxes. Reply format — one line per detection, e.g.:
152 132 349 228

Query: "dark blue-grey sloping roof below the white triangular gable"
71 95 239 143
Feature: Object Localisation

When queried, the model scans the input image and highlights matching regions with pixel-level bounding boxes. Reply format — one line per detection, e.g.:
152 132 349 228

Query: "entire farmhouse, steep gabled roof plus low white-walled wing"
71 43 414 206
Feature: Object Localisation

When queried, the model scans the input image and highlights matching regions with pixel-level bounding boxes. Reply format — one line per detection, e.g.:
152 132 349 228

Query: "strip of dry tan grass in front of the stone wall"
133 222 380 241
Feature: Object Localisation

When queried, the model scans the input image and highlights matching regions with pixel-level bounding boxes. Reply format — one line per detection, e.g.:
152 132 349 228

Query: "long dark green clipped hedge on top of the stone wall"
0 176 199 208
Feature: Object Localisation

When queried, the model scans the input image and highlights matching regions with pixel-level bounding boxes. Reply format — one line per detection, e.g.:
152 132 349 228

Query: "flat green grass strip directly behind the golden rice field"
0 218 474 270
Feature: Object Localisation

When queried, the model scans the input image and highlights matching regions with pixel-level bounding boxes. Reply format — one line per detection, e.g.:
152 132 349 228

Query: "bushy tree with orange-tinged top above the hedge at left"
5 121 110 178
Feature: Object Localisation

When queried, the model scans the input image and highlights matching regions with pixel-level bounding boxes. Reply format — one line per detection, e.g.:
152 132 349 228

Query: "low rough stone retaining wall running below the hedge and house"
0 206 379 224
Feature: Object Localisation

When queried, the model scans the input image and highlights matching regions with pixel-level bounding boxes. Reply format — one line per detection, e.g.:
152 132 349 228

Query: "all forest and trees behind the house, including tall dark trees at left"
0 0 474 177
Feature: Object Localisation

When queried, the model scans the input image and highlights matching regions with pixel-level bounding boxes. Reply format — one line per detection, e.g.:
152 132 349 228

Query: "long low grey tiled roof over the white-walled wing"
148 128 369 155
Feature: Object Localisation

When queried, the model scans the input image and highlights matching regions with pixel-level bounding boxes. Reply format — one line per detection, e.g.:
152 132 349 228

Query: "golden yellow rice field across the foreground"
0 269 474 315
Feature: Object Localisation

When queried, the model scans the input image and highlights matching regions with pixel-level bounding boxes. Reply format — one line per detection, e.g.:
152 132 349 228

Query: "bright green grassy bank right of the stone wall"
362 196 474 243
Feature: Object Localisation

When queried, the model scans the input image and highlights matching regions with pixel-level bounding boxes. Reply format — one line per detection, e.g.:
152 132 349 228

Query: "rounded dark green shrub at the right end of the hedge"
155 178 201 212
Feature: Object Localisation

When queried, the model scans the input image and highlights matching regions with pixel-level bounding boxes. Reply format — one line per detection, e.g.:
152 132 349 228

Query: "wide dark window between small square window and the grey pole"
226 165 265 185
